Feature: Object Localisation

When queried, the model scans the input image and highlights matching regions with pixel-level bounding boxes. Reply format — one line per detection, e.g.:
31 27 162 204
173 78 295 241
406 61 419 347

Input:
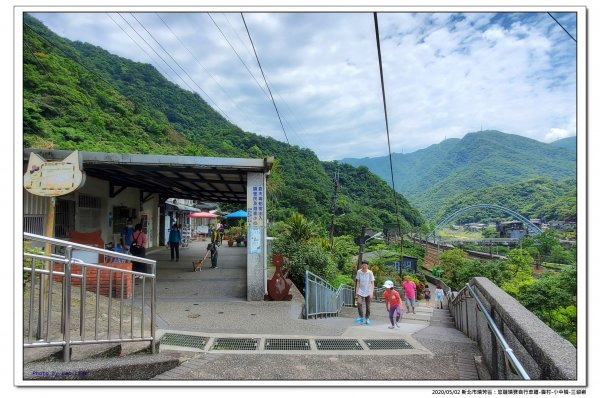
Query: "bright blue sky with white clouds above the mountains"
25 9 577 160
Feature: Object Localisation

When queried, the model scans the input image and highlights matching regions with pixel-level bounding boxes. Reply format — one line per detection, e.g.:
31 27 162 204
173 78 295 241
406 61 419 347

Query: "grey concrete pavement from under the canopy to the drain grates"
138 241 480 383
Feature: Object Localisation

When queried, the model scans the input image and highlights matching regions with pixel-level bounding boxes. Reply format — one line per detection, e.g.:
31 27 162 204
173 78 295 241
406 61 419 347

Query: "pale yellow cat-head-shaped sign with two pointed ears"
23 151 85 196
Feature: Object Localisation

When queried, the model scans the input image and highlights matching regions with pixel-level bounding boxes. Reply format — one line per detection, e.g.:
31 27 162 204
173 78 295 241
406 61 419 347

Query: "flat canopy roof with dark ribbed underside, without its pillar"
23 149 273 203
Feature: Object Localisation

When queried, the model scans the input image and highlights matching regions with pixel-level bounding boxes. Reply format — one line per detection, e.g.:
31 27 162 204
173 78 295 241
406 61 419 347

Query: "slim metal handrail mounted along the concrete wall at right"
446 283 531 380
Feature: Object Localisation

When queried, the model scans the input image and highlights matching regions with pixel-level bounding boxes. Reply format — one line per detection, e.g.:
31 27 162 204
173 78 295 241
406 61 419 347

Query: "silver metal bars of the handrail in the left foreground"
23 233 157 362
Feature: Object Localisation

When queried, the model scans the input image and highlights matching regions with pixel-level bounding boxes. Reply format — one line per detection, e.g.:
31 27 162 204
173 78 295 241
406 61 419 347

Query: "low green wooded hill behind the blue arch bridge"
435 178 577 223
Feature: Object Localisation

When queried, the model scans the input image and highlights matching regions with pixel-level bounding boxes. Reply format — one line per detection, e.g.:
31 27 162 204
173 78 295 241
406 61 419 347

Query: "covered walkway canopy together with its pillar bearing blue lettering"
23 149 273 301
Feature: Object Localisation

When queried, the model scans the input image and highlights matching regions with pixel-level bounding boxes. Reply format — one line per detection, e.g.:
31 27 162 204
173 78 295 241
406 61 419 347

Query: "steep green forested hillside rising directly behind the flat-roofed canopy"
23 15 423 235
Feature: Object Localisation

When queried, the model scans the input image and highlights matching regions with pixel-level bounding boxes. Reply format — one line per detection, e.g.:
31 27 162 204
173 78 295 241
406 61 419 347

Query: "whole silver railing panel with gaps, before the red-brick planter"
23 233 156 362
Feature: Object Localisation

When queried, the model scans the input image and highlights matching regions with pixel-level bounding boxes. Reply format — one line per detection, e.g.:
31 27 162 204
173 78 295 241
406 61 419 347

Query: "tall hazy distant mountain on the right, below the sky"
342 131 576 218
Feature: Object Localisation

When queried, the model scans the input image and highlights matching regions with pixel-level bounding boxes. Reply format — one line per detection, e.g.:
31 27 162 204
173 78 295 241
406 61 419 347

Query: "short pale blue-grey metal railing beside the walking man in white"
304 271 354 319
